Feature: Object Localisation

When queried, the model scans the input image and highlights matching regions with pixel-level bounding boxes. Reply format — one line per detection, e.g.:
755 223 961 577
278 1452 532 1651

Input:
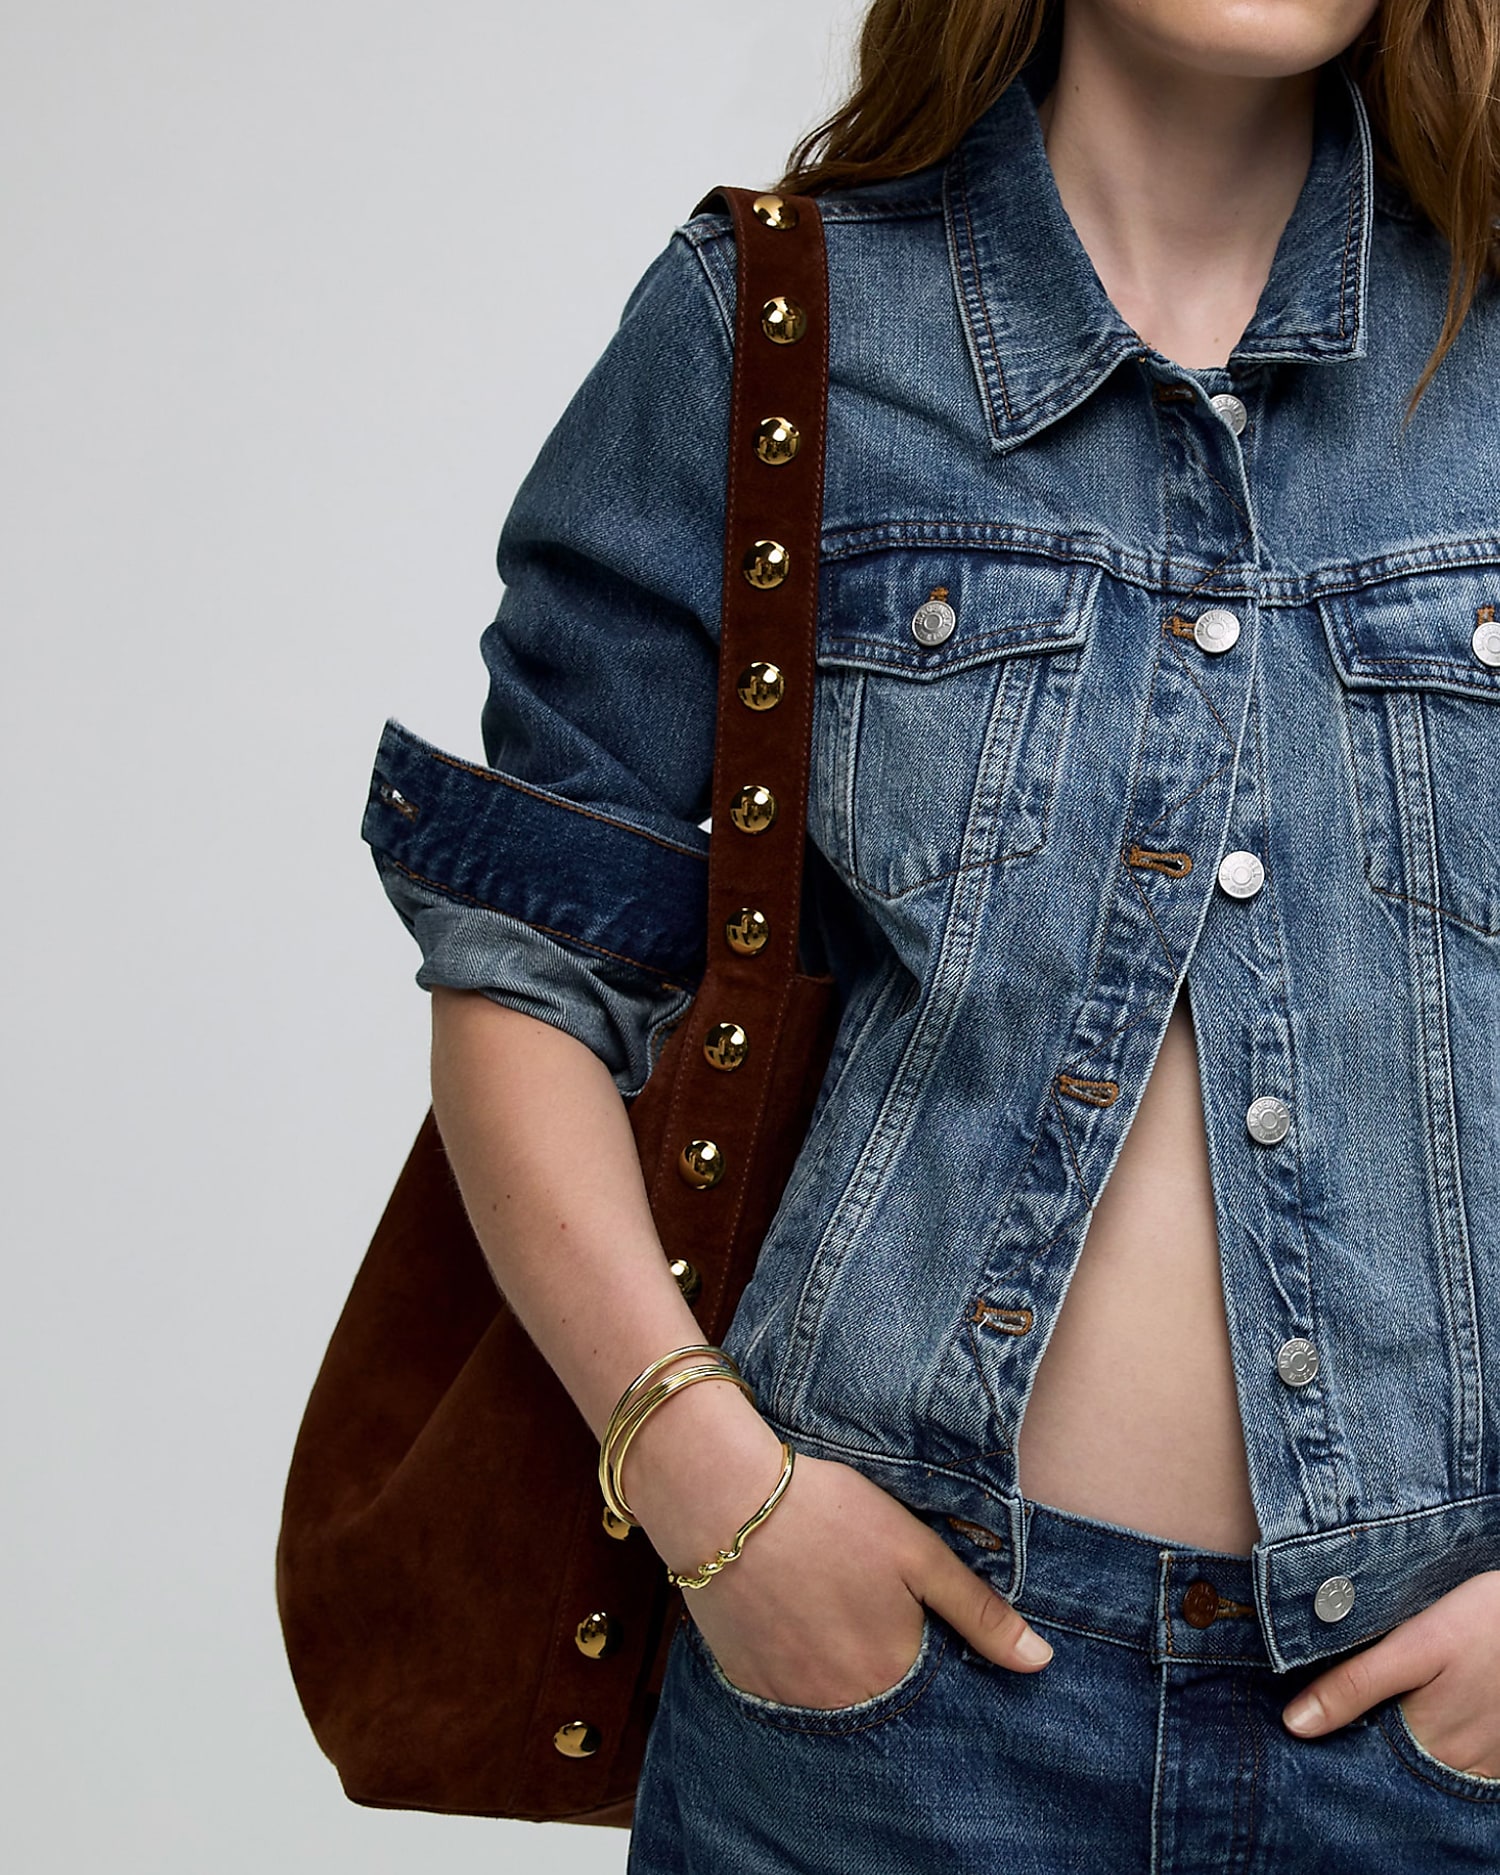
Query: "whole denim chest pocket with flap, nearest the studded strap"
812 548 1099 898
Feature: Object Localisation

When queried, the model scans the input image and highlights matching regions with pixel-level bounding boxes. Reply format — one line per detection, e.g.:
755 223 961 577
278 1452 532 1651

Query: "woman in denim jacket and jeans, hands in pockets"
373 0 1500 1875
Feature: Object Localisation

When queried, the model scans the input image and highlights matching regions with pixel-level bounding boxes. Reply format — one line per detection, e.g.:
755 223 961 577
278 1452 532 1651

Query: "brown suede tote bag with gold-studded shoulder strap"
276 189 836 1824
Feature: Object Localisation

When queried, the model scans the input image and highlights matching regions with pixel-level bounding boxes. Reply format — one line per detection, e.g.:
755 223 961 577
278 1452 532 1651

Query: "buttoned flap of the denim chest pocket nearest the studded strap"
818 546 1097 679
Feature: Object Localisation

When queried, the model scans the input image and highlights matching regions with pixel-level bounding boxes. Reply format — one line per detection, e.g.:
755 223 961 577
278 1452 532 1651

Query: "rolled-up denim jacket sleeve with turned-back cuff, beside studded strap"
362 218 733 1099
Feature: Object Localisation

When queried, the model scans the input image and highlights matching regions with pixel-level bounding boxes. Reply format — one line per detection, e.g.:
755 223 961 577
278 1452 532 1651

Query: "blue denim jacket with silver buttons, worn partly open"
364 62 1500 1667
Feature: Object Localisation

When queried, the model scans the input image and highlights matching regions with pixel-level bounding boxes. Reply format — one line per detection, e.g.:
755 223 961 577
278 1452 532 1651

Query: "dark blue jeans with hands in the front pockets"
628 1502 1500 1875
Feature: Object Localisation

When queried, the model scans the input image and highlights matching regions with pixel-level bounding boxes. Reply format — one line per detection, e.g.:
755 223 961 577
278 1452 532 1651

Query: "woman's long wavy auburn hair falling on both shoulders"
778 0 1500 420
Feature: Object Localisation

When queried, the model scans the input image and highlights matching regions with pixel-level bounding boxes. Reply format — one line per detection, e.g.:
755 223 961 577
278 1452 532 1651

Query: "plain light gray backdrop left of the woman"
0 0 861 1875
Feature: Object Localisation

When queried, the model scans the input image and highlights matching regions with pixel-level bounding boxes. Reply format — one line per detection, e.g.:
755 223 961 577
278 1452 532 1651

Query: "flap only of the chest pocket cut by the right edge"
1318 564 1500 698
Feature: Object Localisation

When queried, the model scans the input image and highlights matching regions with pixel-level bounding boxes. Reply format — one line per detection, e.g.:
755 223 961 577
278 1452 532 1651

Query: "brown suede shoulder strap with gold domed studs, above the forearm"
636 189 829 1339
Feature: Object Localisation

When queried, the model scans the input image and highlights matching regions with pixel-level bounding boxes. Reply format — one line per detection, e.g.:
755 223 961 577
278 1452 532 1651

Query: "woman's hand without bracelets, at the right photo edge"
1281 1569 1500 1778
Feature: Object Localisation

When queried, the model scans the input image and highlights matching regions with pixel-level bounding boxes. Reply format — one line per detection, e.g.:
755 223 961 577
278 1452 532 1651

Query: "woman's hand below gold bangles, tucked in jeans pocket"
626 1386 1052 1706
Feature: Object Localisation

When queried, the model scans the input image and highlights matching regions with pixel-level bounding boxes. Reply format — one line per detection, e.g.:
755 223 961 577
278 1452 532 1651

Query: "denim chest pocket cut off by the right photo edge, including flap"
1318 563 1500 938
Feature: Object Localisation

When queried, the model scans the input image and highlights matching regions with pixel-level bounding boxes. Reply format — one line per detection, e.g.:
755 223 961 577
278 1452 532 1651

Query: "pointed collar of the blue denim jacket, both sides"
943 60 1374 450
